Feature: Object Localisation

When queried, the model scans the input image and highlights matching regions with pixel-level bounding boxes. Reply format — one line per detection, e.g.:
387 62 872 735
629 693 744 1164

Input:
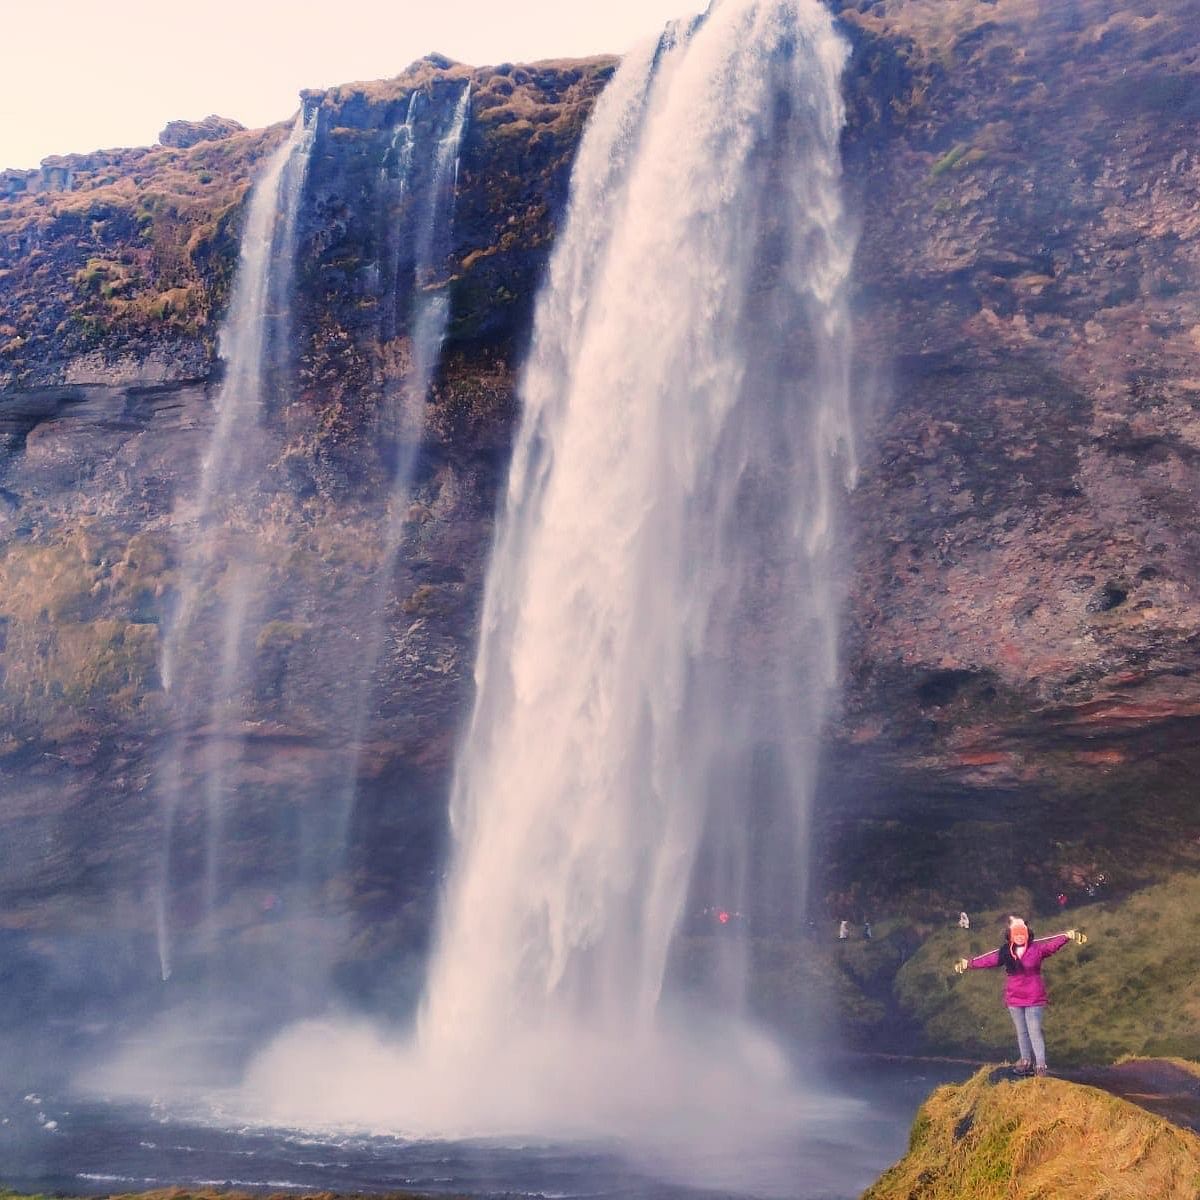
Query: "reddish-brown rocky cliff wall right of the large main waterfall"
811 0 1200 907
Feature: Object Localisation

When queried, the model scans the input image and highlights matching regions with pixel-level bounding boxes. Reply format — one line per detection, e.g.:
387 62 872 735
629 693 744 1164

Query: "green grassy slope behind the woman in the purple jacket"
895 875 1200 1064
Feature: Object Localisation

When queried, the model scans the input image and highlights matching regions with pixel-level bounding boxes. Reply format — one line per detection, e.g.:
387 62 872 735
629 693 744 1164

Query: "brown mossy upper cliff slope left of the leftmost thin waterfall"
0 126 286 388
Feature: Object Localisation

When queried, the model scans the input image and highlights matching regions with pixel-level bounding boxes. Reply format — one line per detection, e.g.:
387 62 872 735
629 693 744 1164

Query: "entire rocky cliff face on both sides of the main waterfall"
0 0 1200 1008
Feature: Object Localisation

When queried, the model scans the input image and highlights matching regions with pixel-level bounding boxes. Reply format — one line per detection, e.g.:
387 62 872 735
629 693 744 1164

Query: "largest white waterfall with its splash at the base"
248 0 854 1136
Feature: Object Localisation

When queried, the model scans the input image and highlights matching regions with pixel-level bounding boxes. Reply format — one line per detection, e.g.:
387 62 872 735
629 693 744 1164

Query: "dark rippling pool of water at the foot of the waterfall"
0 1060 970 1200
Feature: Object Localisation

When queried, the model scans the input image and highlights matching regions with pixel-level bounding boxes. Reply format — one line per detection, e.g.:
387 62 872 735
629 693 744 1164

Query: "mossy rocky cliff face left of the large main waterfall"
0 60 613 984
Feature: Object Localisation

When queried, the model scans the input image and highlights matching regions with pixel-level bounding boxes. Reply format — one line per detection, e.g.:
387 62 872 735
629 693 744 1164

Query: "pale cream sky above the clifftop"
0 0 707 168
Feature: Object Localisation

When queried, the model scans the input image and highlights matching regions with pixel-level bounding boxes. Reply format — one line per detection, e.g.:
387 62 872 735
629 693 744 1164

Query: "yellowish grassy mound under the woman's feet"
863 1070 1200 1200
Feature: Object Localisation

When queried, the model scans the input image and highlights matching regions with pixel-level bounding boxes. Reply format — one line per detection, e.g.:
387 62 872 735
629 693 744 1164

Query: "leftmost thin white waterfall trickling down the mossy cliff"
155 113 314 980
